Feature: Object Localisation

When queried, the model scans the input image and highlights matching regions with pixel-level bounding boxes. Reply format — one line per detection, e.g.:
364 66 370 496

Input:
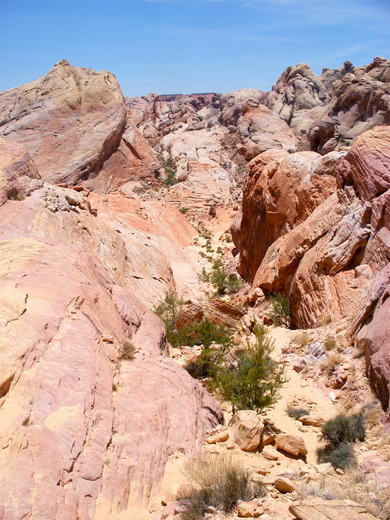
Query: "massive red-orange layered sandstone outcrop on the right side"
232 126 390 418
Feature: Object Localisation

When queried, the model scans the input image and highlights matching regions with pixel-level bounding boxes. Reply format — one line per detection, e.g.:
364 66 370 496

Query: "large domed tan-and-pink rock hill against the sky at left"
0 60 157 191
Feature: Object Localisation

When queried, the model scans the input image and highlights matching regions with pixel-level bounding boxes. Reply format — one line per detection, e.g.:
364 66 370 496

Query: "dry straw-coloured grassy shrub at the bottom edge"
178 455 265 520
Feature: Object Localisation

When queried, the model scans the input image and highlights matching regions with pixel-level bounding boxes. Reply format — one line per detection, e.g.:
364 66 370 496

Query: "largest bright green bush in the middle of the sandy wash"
215 325 284 413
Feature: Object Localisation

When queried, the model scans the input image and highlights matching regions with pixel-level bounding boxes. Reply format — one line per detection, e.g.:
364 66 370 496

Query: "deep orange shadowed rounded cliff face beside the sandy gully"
231 150 342 282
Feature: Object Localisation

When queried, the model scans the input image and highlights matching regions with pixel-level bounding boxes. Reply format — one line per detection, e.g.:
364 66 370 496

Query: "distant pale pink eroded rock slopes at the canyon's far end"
126 89 298 212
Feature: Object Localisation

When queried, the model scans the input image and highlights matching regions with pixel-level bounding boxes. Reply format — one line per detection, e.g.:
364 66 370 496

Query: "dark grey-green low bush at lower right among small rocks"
317 413 366 470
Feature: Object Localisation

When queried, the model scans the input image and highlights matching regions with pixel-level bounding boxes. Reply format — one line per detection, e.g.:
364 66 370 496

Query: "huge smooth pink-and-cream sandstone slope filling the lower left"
0 140 222 520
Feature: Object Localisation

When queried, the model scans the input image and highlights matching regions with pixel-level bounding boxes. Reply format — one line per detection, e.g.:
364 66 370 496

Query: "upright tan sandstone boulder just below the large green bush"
229 410 264 451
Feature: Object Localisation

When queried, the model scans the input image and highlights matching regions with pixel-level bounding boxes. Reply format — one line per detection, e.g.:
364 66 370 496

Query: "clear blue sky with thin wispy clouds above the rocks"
0 0 390 96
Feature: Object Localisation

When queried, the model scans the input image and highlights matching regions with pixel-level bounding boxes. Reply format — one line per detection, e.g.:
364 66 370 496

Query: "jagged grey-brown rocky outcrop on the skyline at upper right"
261 57 390 154
